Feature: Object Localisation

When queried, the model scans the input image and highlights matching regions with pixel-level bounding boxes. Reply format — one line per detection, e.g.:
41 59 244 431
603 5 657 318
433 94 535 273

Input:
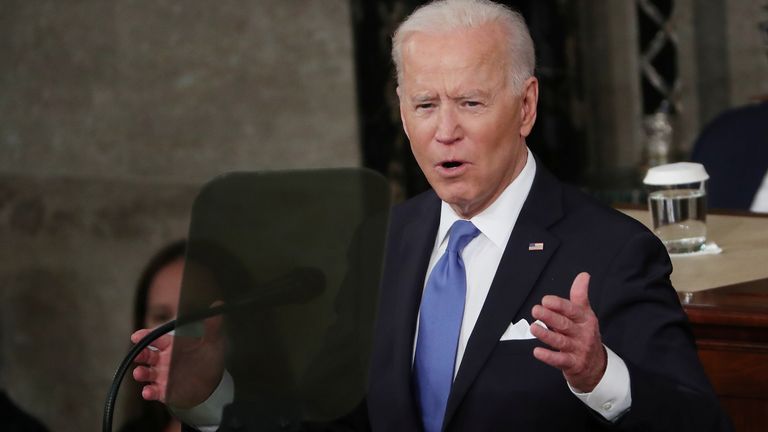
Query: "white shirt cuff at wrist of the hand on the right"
568 345 632 422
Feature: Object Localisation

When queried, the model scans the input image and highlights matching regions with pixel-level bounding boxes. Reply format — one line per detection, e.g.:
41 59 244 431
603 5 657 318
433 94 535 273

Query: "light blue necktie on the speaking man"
413 220 480 432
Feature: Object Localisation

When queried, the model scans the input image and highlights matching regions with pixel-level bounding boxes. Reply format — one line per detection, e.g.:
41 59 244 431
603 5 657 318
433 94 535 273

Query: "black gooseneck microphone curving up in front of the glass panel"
102 267 325 432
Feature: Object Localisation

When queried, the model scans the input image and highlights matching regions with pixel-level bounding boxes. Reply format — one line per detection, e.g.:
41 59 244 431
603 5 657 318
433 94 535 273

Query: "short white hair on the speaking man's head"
392 0 536 92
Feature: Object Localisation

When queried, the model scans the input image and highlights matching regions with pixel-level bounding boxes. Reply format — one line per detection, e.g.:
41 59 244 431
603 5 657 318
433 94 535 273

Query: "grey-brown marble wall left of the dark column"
0 0 360 431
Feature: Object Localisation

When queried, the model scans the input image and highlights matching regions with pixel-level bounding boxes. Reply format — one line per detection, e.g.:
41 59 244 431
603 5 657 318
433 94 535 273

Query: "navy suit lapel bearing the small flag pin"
443 165 562 426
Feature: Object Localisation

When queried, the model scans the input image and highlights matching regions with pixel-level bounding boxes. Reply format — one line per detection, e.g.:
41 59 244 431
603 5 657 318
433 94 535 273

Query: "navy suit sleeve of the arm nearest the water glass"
596 231 731 431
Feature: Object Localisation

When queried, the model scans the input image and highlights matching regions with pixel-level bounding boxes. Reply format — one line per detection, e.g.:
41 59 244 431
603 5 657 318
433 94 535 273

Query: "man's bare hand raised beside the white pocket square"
531 273 608 393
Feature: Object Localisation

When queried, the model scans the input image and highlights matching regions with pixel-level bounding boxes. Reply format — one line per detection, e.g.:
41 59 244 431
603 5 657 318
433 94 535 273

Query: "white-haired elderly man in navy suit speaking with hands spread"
134 0 728 432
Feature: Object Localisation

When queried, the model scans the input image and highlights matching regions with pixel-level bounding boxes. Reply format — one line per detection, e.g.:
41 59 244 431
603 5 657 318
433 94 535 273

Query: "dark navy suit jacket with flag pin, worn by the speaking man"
368 164 729 431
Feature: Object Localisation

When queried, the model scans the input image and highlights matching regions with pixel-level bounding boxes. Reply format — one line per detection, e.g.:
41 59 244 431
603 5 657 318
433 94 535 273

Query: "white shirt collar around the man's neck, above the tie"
437 148 536 249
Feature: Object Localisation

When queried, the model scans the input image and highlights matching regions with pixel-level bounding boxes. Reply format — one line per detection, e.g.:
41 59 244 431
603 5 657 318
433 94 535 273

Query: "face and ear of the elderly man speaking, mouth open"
398 24 538 218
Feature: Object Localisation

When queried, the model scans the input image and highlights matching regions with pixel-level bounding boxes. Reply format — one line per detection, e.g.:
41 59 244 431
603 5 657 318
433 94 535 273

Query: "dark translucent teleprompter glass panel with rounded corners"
168 169 389 430
